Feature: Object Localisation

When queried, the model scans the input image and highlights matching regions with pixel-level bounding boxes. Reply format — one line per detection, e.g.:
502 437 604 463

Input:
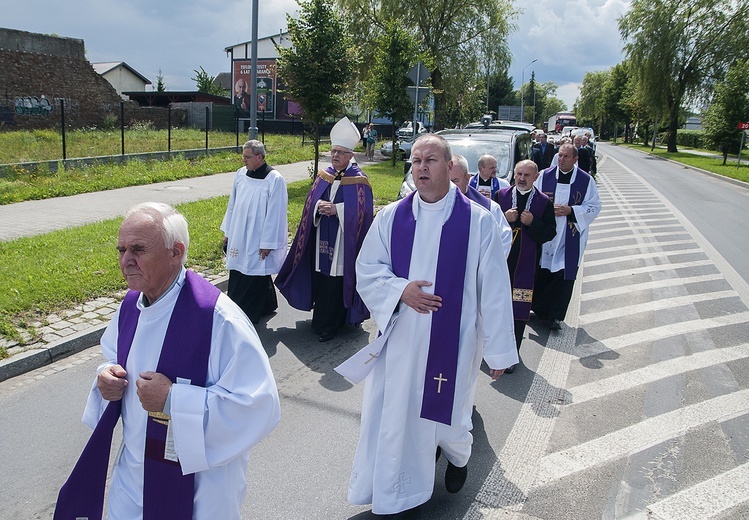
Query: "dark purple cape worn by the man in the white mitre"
275 164 373 324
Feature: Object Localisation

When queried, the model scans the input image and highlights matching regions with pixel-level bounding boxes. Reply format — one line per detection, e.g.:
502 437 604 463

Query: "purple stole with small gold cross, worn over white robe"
390 190 468 425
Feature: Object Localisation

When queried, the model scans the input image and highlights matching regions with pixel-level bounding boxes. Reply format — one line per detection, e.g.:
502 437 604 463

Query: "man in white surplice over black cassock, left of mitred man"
221 140 289 324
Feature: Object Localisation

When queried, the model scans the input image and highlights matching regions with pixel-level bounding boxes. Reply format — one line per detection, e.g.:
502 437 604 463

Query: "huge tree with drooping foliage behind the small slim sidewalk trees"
337 0 517 129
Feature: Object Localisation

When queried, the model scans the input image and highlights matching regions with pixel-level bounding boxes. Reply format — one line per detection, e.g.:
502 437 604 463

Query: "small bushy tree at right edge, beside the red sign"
702 59 749 165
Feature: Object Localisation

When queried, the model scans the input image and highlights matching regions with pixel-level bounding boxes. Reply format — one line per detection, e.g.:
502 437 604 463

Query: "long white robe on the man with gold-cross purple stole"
348 185 518 514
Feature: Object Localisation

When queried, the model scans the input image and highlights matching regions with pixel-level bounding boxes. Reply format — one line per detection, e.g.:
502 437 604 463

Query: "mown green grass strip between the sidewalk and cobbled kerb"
0 156 410 346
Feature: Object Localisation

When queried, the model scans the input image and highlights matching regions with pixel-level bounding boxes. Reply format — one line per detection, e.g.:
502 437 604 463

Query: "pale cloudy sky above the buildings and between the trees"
7 0 629 114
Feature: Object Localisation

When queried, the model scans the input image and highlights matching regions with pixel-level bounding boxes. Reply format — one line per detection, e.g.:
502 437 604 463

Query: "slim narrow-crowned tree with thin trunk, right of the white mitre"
367 18 416 166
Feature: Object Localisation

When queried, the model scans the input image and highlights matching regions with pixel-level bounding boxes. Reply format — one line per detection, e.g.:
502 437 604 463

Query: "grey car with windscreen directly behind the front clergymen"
398 127 532 198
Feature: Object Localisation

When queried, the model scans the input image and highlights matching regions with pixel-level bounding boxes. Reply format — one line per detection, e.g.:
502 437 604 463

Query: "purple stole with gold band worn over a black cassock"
497 186 549 321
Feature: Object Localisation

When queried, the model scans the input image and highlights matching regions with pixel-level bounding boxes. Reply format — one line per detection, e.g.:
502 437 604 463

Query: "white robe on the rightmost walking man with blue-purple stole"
534 165 601 273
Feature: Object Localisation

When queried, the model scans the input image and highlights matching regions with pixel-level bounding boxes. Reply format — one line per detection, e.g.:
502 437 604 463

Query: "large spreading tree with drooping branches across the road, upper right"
619 0 749 152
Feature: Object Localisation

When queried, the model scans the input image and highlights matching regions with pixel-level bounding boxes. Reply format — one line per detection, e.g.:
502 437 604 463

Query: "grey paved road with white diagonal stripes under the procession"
0 143 749 520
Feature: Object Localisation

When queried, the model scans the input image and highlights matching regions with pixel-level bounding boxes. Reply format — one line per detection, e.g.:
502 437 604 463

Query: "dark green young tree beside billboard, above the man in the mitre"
277 0 356 172
